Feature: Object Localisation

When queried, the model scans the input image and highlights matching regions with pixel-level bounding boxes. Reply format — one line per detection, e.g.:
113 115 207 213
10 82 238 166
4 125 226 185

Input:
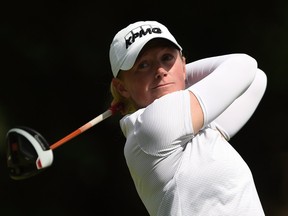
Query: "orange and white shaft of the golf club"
50 109 113 150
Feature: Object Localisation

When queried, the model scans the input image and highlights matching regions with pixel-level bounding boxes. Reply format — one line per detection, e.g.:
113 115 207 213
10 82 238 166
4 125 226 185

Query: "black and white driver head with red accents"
6 127 53 180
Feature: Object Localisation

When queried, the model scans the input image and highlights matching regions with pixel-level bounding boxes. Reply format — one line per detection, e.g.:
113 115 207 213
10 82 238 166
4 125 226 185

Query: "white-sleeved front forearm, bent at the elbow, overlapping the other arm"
188 54 257 129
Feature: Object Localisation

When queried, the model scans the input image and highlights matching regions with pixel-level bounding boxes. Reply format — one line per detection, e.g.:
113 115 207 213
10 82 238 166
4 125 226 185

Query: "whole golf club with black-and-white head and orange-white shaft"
6 104 122 180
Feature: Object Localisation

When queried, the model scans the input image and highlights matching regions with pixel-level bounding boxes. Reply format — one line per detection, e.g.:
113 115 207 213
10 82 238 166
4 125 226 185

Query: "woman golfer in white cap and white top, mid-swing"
110 21 267 216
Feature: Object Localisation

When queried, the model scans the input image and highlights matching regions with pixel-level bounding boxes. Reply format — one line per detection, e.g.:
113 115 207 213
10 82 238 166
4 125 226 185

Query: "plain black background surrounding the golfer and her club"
0 0 288 216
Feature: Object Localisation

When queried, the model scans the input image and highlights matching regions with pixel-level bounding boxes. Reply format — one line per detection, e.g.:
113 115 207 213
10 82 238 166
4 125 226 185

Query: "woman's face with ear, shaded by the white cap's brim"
113 46 186 108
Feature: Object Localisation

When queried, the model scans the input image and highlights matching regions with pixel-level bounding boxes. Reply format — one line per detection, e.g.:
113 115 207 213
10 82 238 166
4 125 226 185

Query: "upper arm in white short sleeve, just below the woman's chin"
133 91 194 155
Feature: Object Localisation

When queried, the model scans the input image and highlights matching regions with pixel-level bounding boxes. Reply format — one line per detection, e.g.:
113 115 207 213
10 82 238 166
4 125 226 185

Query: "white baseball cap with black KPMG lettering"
109 21 182 77
